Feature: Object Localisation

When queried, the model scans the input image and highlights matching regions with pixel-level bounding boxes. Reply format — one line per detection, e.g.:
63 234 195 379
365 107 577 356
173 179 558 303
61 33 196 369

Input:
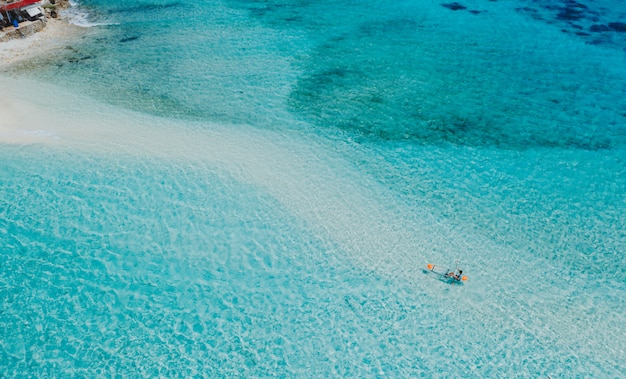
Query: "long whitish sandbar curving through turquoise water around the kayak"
0 77 624 372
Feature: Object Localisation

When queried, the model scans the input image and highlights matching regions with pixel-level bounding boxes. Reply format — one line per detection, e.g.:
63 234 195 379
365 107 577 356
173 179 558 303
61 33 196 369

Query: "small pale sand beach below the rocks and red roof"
0 17 87 74
